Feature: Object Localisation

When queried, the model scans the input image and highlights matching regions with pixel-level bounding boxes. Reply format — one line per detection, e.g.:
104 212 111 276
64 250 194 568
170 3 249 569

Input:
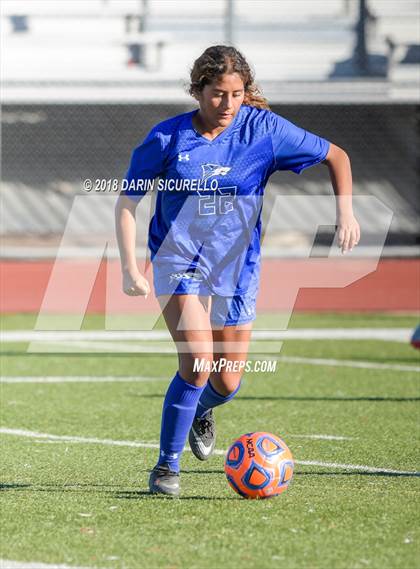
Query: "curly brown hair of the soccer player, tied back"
188 45 270 109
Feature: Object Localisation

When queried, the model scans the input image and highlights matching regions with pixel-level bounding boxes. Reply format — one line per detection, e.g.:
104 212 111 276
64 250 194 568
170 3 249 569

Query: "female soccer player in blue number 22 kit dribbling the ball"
116 45 360 496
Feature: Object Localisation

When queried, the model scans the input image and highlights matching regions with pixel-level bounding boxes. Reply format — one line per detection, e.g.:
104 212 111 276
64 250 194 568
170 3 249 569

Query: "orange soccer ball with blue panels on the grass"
225 432 294 498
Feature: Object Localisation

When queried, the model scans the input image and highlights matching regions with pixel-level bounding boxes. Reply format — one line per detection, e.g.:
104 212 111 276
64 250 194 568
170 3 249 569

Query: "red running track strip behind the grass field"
0 258 420 314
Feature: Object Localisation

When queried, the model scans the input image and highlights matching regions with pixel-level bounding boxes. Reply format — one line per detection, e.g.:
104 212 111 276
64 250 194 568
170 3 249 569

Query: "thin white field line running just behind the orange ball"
0 427 420 476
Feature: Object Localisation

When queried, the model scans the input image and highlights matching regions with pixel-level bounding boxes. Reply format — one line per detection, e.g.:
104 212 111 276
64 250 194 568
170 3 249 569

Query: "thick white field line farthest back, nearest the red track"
0 328 413 342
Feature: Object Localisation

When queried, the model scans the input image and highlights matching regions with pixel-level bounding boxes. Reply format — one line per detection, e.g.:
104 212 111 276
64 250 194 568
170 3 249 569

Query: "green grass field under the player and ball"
0 314 420 569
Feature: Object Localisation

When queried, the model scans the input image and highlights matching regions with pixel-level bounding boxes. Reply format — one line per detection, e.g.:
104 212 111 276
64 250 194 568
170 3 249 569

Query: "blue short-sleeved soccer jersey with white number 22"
123 105 329 296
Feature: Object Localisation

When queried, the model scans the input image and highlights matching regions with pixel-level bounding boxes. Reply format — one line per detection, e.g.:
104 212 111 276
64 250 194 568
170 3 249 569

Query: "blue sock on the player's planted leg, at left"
158 372 205 472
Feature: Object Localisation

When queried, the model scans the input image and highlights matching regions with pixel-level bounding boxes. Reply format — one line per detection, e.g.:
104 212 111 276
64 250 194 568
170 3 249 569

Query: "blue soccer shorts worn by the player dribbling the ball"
153 264 257 326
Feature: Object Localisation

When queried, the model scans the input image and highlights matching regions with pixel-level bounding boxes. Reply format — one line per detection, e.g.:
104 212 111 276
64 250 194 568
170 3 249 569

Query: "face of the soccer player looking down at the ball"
198 73 245 128
